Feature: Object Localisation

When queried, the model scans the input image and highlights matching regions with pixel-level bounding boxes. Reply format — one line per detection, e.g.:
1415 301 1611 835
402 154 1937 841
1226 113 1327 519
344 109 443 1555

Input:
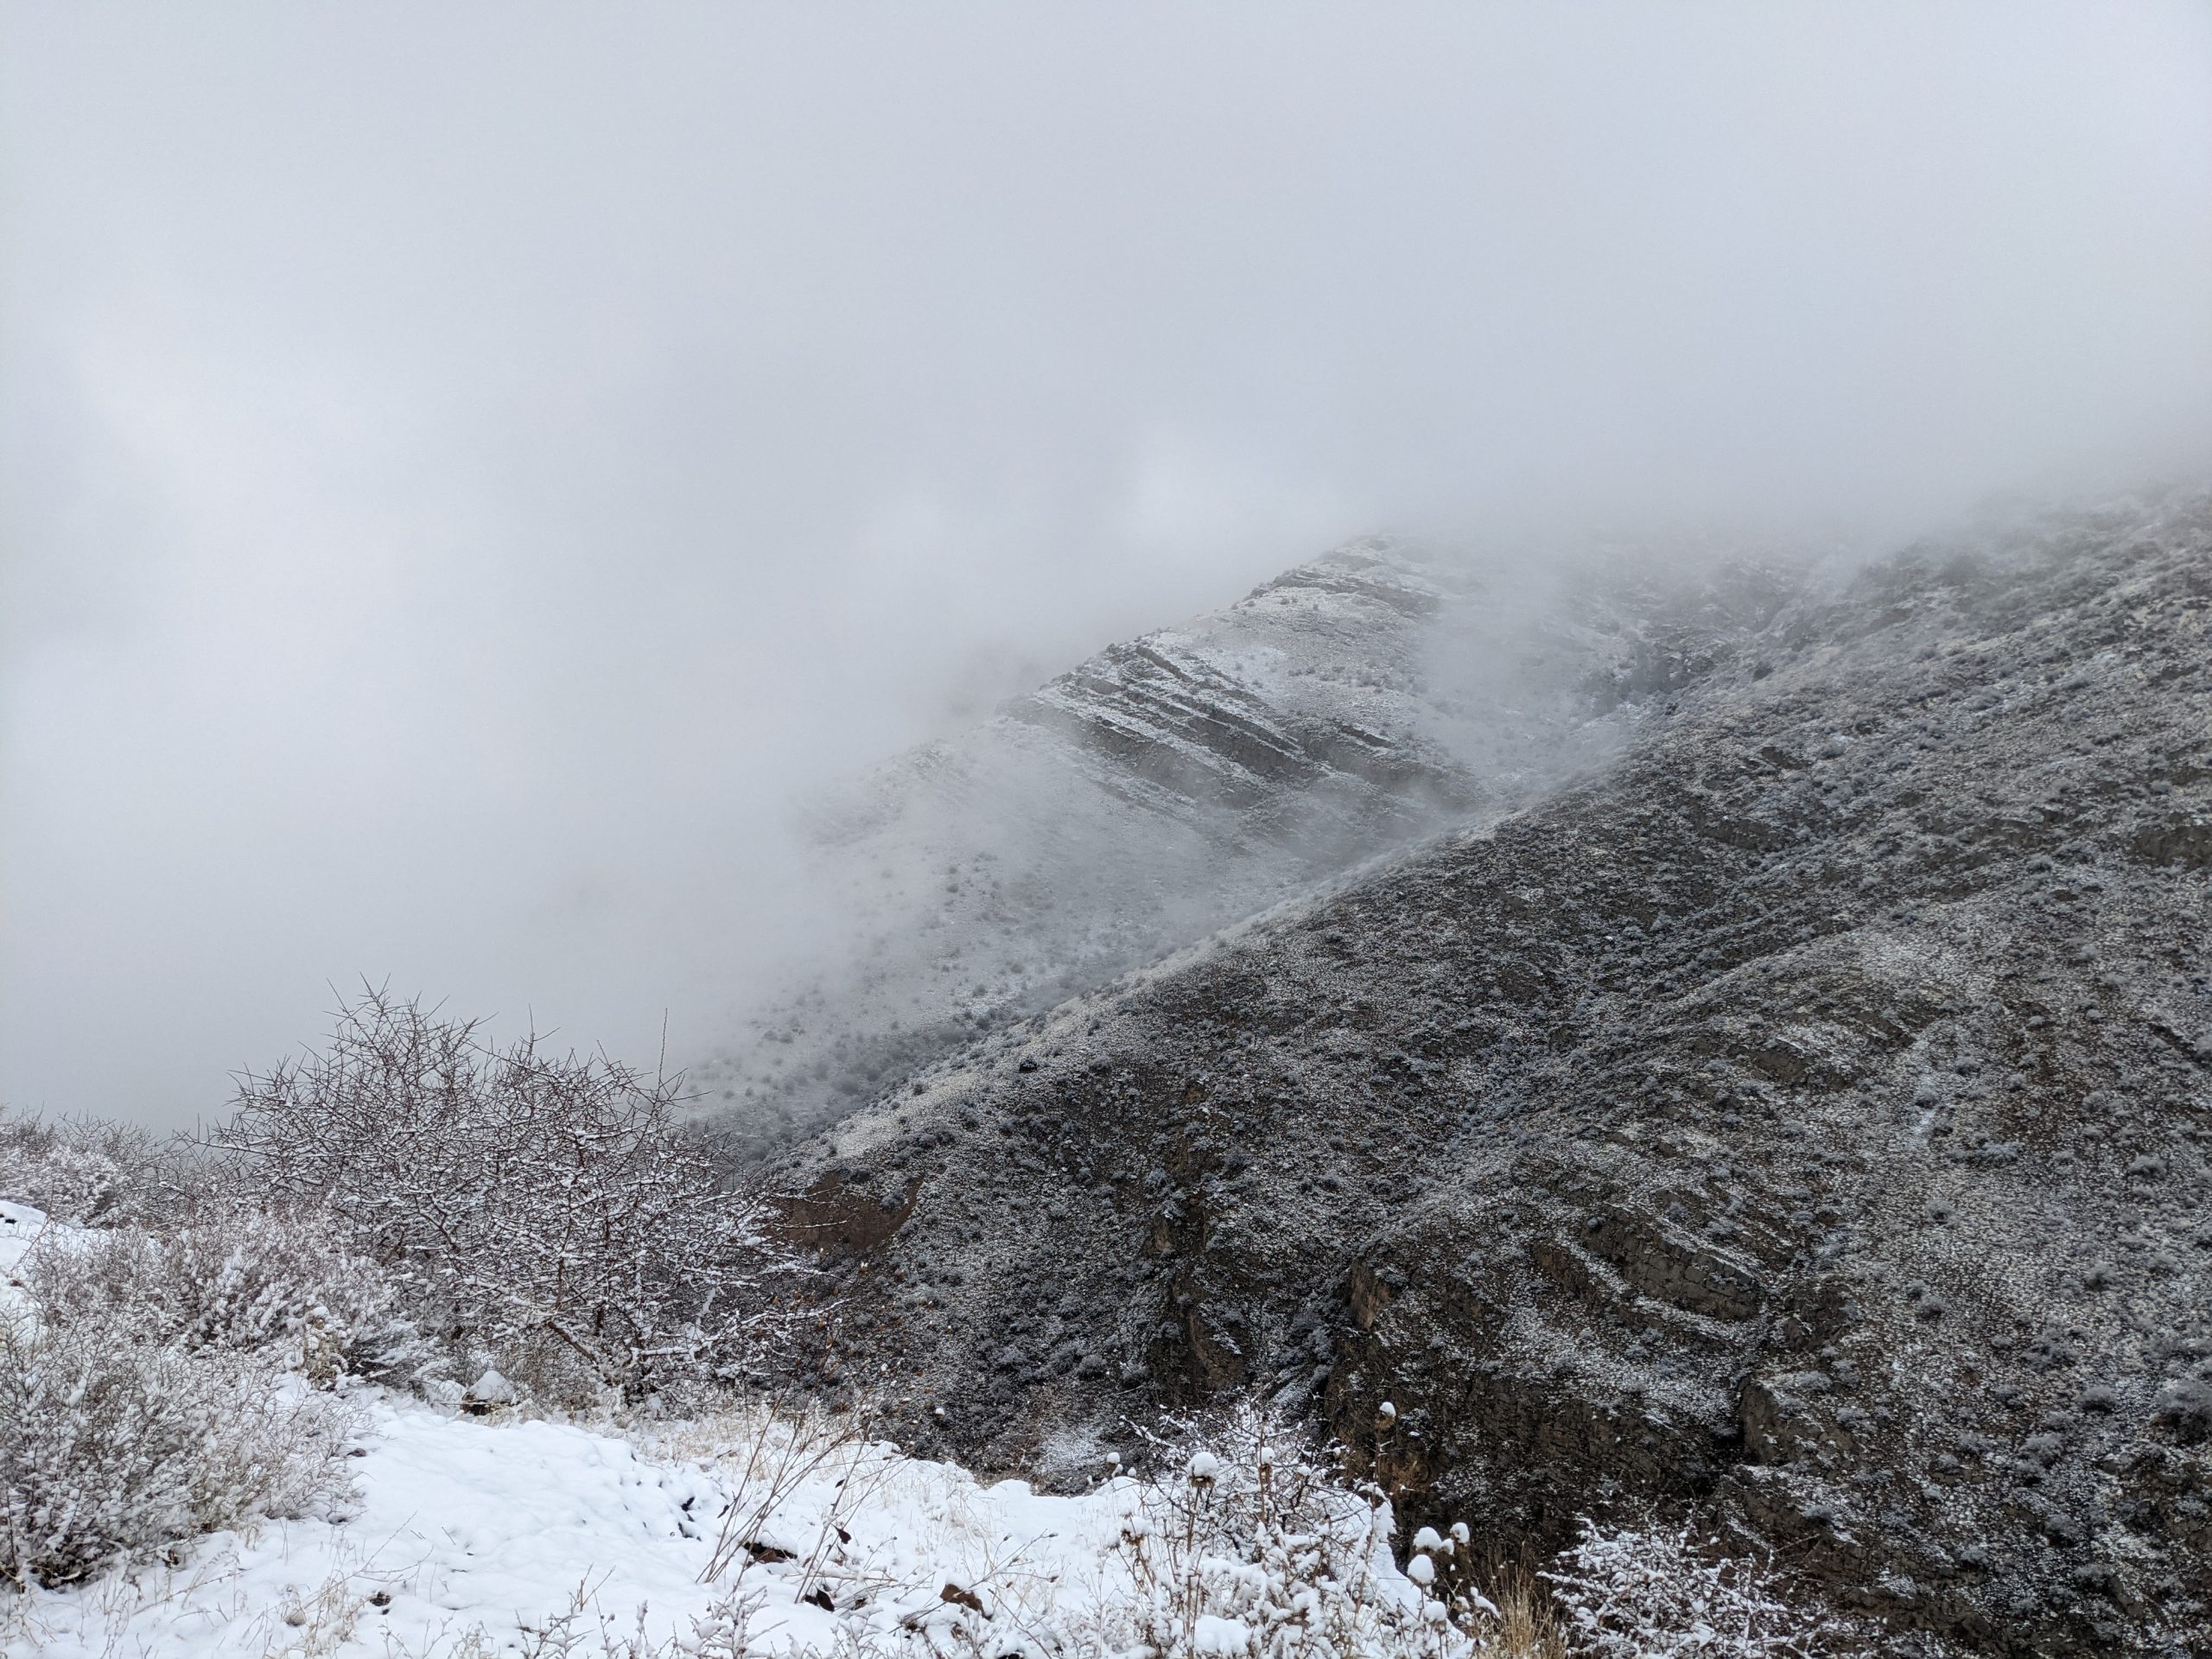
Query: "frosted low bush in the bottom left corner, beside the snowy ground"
0 1239 352 1586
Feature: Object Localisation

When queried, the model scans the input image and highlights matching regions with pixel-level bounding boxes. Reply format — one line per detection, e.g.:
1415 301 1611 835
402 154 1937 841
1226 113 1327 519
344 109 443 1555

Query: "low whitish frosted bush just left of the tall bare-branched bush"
24 1205 438 1382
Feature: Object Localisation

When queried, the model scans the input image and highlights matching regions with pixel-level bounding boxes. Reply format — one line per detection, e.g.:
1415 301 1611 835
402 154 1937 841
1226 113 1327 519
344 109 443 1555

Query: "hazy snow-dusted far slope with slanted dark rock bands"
695 537 1796 1139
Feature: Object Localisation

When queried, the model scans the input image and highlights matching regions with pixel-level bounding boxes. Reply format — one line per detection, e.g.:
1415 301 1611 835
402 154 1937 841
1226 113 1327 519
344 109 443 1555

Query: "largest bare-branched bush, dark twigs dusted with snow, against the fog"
210 993 785 1398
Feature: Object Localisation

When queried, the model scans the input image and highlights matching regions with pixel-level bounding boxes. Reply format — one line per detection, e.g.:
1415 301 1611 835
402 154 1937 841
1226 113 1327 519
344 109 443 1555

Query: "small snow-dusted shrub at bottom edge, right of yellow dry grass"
1544 1520 1842 1659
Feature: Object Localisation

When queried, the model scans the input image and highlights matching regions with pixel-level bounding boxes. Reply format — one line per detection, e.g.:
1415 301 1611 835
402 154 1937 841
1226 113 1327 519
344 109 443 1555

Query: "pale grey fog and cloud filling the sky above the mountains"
0 0 2212 1123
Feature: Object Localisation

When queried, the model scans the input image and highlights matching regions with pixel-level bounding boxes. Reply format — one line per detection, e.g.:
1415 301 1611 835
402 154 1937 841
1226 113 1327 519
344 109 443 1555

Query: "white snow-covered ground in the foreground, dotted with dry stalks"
0 1391 1422 1659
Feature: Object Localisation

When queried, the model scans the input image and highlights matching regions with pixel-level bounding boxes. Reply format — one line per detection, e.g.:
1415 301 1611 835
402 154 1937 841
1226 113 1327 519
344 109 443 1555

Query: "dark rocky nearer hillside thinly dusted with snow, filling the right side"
790 500 2212 1652
